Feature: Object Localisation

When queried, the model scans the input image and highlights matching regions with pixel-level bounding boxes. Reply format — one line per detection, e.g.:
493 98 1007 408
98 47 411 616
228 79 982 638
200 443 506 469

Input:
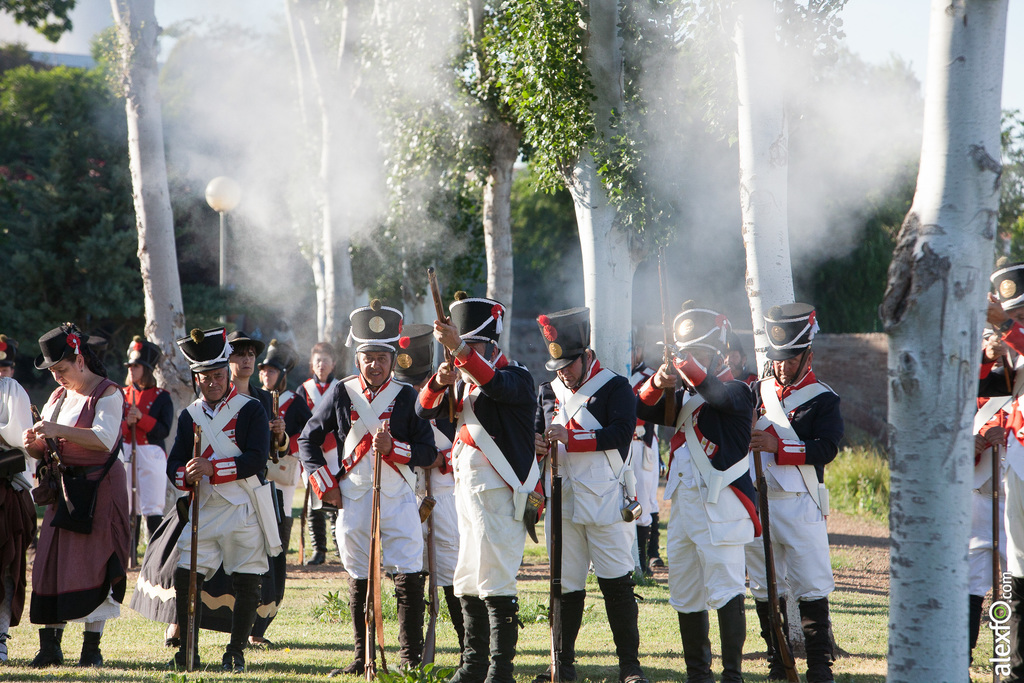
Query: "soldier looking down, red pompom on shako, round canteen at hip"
534 308 647 683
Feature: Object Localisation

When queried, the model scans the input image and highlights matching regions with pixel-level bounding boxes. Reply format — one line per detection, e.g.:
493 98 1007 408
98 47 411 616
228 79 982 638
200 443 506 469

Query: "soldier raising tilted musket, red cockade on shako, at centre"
417 292 540 683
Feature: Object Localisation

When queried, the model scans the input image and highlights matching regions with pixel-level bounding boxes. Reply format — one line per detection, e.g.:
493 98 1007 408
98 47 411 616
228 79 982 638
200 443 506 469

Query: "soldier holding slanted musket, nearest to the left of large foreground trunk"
746 303 843 683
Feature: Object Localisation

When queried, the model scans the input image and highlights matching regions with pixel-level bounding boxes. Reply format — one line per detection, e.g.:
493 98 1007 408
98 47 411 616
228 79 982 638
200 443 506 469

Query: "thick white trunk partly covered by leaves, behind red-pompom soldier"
567 0 636 373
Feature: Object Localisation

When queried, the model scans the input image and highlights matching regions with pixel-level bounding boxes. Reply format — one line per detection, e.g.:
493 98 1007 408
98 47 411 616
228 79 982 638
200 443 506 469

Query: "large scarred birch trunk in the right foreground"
880 0 1007 683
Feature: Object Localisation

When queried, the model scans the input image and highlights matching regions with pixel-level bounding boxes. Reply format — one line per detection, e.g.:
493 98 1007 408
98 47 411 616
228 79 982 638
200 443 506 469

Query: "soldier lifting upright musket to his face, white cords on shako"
637 301 761 683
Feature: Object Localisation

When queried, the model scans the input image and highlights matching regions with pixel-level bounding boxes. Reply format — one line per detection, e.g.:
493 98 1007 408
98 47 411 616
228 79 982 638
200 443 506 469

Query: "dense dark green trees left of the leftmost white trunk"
0 60 142 358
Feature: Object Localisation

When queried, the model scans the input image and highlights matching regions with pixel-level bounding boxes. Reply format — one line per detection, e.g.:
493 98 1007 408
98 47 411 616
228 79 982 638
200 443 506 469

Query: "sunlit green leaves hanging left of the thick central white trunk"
484 0 596 190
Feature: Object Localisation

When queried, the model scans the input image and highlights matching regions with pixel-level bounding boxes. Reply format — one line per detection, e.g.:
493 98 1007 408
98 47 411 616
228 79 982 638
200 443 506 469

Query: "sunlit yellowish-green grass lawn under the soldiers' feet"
0 505 897 683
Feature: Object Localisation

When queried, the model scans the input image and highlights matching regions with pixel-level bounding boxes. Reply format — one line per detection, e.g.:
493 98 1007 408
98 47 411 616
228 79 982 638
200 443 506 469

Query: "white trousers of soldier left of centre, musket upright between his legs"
337 484 423 579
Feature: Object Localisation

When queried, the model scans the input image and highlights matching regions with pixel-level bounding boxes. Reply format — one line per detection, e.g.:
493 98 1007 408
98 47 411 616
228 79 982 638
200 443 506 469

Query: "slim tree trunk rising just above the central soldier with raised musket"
483 121 521 349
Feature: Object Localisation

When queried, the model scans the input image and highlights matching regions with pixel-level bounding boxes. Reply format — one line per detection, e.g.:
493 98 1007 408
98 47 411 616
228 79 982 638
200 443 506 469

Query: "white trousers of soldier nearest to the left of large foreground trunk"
746 492 836 600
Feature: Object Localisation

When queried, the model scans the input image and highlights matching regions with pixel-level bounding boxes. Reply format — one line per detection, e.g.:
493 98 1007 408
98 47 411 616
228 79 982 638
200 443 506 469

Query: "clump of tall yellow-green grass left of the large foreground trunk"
825 447 889 521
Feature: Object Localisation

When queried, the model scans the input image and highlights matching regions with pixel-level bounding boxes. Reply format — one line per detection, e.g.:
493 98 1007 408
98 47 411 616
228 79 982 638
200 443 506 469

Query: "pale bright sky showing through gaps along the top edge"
0 0 1024 110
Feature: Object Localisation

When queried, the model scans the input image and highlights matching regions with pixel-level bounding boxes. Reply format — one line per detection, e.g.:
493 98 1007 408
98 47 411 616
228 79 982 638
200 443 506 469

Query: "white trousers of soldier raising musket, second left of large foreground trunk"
666 485 751 612
